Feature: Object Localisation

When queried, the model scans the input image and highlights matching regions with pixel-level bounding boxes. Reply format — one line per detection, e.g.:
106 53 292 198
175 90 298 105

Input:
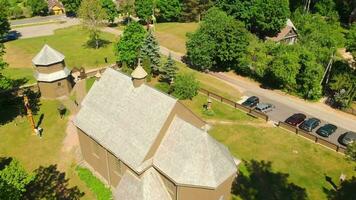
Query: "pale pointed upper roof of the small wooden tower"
32 44 65 66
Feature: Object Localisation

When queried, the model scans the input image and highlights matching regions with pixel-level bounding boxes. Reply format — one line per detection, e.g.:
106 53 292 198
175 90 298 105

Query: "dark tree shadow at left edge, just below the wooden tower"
0 89 41 125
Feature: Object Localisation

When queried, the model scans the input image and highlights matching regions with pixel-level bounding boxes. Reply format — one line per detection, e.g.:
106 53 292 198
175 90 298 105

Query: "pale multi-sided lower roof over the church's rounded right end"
153 117 237 188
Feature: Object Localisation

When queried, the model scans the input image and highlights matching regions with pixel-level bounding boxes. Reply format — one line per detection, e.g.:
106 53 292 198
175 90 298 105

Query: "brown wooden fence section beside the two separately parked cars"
199 88 269 121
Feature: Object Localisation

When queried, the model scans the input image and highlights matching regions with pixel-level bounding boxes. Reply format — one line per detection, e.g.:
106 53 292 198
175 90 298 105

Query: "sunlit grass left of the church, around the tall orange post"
0 100 94 200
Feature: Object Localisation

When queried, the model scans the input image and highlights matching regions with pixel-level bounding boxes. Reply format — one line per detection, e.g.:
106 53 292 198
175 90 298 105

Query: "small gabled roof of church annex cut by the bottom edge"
114 167 171 200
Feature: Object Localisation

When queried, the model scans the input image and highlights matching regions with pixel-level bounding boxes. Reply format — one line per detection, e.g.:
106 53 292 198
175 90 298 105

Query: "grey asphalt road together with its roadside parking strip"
213 73 356 148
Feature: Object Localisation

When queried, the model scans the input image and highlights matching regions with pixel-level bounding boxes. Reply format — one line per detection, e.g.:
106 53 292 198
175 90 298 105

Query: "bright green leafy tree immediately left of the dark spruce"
115 22 146 68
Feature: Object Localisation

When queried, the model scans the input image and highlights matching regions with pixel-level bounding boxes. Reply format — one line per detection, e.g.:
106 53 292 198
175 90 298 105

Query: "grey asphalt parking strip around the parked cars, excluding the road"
243 92 350 145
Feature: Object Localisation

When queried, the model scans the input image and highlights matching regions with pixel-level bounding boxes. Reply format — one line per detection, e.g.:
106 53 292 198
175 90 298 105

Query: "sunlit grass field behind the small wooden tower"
4 26 117 69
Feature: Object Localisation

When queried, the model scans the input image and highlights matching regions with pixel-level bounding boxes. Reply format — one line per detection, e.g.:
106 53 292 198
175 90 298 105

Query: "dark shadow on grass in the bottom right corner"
323 176 356 200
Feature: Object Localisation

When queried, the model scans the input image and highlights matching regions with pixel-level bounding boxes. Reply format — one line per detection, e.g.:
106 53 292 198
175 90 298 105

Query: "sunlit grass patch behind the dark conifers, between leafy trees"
155 23 199 53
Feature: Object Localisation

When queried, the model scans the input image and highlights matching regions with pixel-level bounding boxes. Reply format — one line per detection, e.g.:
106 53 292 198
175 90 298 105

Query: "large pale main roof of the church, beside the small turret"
74 68 177 172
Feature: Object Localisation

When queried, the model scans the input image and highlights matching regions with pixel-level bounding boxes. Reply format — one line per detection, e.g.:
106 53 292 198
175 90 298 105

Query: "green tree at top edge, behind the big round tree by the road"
217 0 290 38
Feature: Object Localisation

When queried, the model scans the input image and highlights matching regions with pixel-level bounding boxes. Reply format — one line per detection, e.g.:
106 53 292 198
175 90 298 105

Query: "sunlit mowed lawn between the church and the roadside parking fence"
183 95 356 200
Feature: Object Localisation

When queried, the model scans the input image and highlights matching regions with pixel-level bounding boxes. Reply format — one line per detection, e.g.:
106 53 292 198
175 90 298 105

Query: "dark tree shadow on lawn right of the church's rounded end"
232 160 307 200
